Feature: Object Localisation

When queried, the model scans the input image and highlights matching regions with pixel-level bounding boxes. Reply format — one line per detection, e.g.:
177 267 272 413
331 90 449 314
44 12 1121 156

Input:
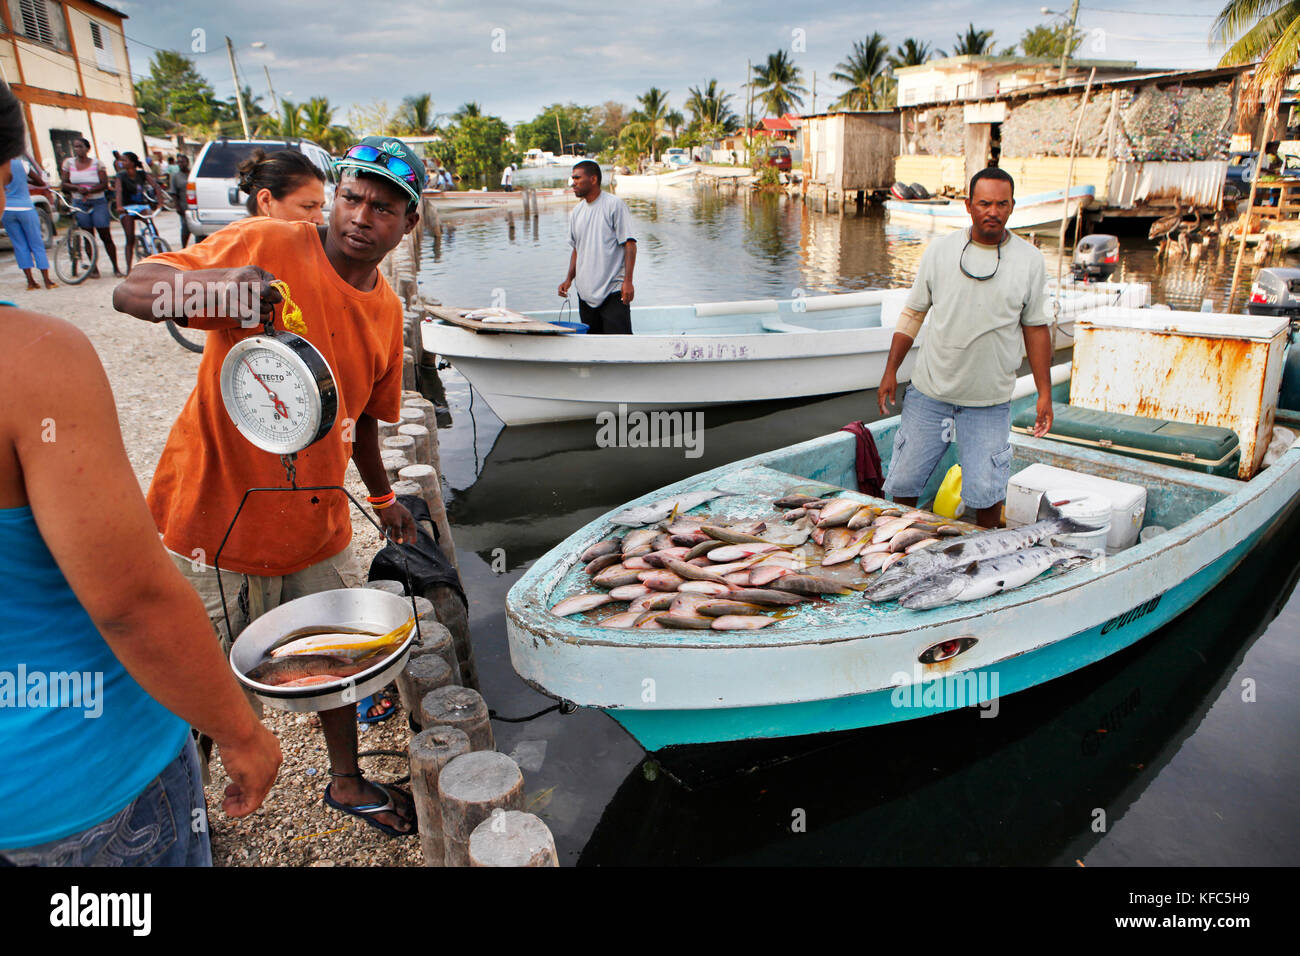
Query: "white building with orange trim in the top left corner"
0 0 144 178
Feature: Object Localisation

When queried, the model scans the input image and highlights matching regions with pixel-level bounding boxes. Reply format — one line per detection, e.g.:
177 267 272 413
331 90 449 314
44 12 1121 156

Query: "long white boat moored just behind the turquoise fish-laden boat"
423 284 1147 425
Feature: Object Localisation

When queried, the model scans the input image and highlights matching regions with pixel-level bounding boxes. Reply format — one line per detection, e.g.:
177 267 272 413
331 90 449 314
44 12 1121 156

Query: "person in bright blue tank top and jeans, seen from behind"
0 83 280 869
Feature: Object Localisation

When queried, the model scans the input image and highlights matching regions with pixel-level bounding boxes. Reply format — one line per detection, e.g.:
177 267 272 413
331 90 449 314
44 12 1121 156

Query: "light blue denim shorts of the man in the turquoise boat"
885 385 1011 509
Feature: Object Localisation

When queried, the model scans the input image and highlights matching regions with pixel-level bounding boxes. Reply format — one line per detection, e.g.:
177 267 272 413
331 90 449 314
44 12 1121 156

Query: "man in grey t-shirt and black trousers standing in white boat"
559 160 637 336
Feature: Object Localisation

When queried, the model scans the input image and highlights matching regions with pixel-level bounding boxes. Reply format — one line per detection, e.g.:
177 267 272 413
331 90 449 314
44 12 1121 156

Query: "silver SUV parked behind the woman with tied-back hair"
185 139 338 237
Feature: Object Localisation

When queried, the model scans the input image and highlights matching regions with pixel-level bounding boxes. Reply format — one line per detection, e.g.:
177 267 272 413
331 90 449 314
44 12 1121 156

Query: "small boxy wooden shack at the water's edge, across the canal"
802 109 898 199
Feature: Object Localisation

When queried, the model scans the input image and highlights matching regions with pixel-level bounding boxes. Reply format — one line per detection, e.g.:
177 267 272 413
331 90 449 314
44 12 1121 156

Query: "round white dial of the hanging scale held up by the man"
221 332 338 455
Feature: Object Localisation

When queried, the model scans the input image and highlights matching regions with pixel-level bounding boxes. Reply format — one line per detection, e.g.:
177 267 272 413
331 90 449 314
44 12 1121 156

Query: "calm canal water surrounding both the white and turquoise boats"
421 187 1300 866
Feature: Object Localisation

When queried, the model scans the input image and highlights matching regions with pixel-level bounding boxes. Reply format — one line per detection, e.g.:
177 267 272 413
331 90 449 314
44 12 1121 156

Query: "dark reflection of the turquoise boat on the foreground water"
579 510 1300 866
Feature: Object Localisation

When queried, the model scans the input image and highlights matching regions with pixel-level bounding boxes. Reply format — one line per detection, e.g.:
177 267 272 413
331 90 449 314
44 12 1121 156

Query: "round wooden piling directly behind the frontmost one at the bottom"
438 750 524 866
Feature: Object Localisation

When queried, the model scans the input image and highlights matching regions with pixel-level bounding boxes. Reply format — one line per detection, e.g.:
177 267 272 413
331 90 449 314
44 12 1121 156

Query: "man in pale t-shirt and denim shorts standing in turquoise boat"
878 166 1052 528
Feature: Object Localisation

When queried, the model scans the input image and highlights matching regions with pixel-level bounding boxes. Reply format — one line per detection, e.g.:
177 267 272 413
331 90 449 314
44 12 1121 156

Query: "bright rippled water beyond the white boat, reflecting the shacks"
421 183 1294 311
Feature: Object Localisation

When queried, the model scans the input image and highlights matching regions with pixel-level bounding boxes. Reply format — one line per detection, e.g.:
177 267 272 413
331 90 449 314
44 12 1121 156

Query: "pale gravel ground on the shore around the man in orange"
0 213 423 866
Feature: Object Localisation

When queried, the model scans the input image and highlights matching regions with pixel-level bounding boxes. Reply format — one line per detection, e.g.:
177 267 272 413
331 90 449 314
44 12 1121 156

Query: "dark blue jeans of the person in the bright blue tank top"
0 739 212 866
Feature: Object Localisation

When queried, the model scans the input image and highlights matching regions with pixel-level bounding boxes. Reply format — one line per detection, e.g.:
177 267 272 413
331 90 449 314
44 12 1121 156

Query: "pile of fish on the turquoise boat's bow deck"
551 489 1097 631
